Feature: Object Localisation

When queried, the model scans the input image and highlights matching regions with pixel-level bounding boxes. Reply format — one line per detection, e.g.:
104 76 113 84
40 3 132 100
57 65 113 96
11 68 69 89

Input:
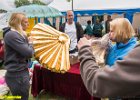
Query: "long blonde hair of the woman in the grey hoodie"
9 13 26 33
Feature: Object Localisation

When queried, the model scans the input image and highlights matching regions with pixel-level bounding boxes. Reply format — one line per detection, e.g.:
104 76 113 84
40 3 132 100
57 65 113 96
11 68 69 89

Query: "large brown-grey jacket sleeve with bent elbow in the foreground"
79 45 140 98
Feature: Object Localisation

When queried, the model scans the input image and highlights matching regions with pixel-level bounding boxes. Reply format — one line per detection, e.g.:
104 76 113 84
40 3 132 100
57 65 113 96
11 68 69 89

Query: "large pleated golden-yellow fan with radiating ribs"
31 23 70 73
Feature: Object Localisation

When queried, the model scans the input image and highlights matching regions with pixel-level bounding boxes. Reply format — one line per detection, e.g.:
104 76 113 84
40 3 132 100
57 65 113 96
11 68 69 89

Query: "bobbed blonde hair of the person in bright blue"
110 18 134 42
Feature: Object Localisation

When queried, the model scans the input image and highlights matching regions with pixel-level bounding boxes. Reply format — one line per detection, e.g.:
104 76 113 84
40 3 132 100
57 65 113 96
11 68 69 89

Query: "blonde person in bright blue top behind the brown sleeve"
106 18 137 67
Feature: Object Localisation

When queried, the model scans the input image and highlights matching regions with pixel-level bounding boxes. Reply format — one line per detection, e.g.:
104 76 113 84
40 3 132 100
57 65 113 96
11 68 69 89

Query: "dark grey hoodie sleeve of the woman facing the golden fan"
4 32 34 58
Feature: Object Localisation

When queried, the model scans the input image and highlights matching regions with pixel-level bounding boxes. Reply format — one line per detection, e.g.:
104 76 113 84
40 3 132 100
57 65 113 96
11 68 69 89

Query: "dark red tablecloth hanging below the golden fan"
31 63 100 100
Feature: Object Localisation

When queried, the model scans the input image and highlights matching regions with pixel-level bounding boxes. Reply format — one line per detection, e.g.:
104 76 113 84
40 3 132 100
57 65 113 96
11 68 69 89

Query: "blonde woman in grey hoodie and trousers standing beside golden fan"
4 13 34 100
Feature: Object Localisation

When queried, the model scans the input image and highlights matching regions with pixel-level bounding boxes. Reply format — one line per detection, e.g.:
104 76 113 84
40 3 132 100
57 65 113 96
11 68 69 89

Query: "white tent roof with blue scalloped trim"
50 0 140 22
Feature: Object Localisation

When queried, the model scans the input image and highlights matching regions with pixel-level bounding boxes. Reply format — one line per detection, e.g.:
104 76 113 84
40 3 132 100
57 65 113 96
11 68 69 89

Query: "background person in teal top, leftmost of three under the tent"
84 20 93 39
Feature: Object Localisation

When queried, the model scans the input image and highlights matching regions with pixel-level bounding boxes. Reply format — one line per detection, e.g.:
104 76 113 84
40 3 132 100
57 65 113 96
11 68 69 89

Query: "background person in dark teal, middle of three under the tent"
93 18 103 37
